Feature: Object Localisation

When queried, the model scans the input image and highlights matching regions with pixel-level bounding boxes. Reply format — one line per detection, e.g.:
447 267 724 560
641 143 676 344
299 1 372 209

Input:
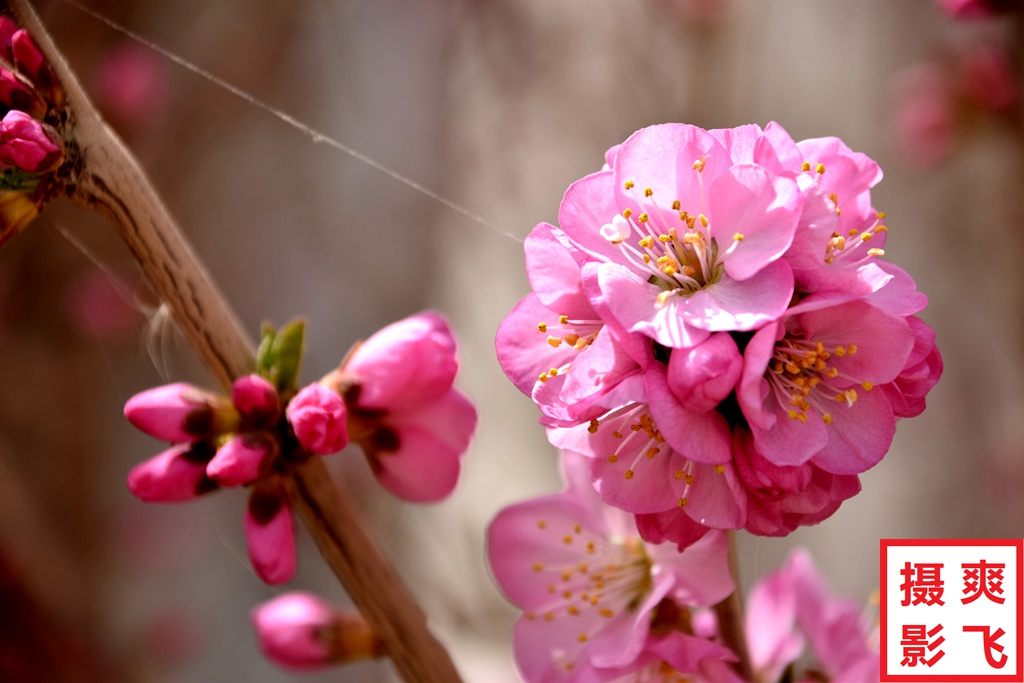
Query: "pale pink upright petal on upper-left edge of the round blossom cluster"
523 223 597 323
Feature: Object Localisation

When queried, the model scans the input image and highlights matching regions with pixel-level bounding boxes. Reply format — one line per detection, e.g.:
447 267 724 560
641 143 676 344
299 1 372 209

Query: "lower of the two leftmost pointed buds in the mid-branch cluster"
128 442 217 503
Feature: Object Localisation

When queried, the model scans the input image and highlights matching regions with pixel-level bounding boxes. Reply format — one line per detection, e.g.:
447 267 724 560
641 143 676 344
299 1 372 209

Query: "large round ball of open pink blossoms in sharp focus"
496 123 942 548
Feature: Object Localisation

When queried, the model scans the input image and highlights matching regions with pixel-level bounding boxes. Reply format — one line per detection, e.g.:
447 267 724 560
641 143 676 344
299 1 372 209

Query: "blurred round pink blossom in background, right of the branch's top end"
95 40 170 127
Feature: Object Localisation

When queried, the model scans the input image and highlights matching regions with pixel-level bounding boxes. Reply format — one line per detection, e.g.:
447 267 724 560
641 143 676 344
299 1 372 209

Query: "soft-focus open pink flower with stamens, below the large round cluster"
487 454 733 681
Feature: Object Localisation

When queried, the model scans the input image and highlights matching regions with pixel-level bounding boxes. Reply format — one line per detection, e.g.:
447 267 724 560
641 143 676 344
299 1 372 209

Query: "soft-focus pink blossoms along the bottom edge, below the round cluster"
487 453 879 683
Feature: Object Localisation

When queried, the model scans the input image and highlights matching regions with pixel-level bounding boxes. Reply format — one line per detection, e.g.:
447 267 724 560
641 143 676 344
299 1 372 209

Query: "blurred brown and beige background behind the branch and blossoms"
0 0 1024 682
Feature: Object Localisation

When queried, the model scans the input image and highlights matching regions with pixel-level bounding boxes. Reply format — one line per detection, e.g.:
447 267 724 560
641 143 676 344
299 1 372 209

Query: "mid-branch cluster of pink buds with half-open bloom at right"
125 312 476 585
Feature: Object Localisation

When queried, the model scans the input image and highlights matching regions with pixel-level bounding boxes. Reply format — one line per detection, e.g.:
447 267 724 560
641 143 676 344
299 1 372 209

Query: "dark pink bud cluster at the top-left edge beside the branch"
0 14 65 244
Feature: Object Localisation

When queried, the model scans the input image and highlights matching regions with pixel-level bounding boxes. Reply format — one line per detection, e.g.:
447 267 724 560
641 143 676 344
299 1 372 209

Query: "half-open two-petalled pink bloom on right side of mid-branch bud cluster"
331 312 476 503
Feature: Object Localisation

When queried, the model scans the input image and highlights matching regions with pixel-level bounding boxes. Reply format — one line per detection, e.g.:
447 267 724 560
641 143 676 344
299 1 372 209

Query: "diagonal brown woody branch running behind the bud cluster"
9 0 460 683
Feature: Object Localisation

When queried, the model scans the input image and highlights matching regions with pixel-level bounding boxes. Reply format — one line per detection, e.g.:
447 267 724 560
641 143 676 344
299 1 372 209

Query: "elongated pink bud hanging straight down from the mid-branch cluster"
244 488 296 586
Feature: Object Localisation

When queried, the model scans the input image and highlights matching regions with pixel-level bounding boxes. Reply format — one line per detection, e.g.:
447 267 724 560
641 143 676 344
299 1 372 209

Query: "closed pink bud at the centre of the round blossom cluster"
669 333 743 413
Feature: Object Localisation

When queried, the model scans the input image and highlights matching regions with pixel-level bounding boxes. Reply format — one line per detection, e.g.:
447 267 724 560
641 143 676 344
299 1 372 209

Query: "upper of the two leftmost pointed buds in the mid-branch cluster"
125 382 239 443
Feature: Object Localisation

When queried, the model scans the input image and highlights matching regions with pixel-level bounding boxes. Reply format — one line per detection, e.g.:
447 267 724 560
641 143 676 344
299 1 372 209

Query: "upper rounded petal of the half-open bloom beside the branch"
344 311 459 410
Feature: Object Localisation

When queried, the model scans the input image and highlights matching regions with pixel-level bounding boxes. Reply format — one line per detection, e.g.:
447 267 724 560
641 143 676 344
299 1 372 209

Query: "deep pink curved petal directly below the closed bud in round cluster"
645 364 732 465
